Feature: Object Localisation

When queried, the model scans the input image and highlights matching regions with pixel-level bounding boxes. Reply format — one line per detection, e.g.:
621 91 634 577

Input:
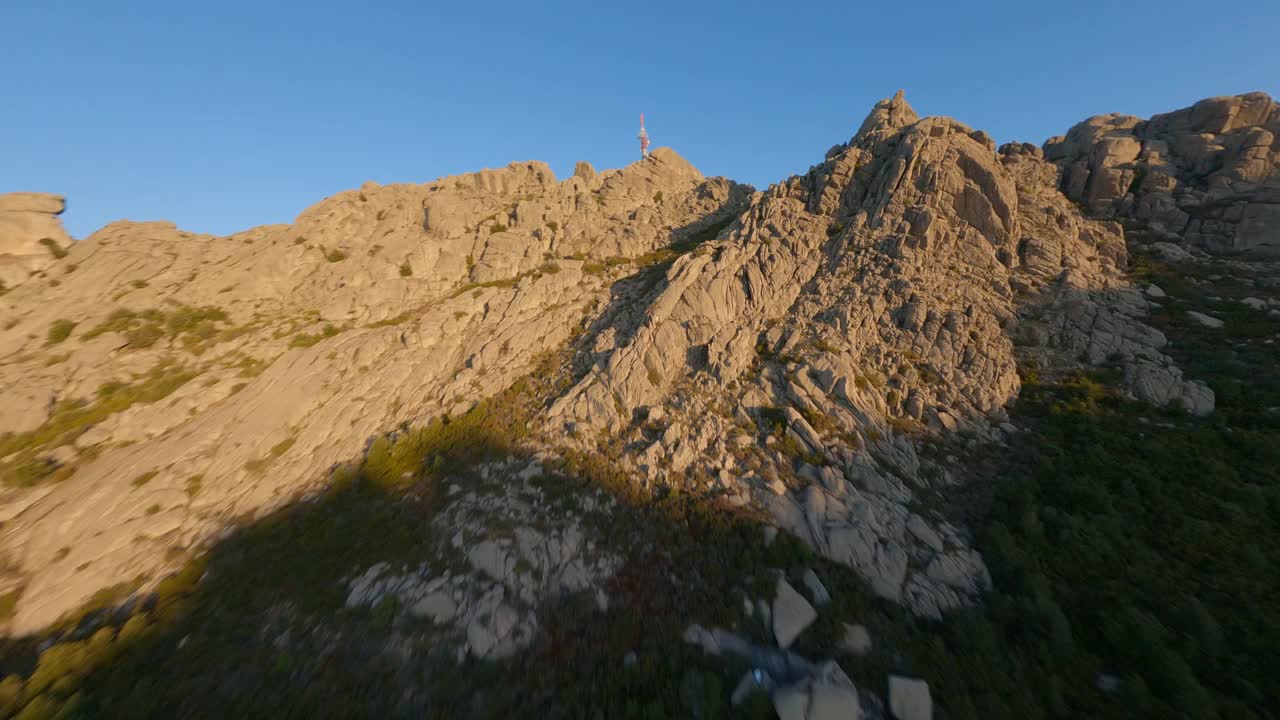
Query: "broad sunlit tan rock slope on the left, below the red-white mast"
0 149 750 632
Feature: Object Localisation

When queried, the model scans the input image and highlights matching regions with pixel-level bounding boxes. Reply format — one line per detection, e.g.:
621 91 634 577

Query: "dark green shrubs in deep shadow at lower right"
860 254 1280 719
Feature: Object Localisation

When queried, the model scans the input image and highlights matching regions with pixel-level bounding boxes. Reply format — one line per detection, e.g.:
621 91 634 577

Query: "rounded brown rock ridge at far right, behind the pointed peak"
1044 92 1280 256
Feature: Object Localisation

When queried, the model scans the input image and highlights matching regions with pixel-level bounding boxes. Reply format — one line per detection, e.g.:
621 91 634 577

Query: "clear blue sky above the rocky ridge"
0 0 1280 237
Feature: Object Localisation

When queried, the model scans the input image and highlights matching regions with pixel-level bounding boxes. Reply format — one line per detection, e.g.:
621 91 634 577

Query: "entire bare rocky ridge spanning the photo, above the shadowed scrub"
0 88 1280 638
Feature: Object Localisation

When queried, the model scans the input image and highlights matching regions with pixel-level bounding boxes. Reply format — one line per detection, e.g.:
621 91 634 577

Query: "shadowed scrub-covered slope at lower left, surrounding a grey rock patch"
0 380 921 717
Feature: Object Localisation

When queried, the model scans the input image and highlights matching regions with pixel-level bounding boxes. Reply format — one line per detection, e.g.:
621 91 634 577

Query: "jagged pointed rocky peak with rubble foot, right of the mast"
552 94 1212 618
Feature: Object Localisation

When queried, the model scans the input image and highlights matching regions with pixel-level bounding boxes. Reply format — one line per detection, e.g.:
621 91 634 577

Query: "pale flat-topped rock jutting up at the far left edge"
0 192 72 293
